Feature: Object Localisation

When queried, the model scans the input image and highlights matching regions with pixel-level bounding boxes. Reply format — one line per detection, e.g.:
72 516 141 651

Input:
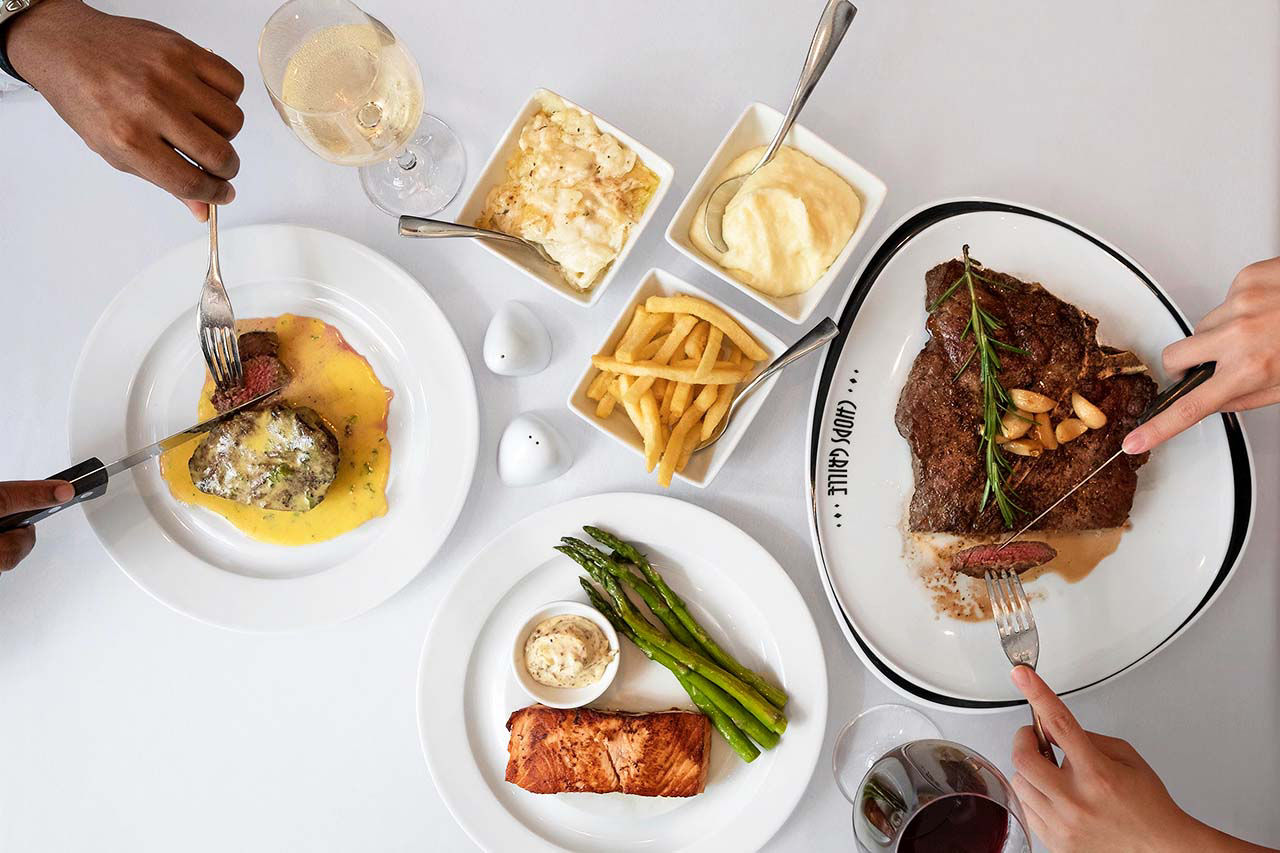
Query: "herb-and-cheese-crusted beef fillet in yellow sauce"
188 403 338 512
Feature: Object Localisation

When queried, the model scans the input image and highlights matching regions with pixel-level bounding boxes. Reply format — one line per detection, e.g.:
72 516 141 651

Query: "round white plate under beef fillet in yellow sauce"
70 225 479 630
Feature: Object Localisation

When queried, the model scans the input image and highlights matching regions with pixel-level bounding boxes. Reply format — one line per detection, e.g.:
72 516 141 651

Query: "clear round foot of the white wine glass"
360 114 467 216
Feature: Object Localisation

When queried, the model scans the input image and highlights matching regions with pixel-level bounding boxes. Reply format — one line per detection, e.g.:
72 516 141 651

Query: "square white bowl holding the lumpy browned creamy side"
458 88 676 306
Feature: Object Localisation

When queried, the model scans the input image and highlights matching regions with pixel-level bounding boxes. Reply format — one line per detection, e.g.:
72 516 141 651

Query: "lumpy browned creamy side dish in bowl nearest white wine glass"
476 92 658 291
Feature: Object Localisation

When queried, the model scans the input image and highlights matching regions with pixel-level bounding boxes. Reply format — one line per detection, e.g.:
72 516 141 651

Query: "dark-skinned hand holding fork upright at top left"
0 0 244 222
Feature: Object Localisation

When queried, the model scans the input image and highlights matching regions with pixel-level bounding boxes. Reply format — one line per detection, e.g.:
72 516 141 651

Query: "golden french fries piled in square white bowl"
586 295 768 488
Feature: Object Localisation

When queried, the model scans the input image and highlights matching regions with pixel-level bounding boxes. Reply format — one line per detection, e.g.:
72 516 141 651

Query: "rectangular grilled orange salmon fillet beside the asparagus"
507 704 712 797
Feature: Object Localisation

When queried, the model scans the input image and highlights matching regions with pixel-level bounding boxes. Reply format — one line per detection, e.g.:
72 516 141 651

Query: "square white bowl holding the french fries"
568 268 785 488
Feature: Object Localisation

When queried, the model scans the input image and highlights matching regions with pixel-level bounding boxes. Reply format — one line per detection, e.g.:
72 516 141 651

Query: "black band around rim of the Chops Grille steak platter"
808 199 1253 711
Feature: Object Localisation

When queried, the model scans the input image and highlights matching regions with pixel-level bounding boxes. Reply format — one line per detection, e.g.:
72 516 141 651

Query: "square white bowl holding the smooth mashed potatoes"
667 104 888 323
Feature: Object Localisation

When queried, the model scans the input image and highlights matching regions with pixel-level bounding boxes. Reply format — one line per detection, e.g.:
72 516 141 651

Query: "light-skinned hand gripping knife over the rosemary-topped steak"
1124 257 1280 453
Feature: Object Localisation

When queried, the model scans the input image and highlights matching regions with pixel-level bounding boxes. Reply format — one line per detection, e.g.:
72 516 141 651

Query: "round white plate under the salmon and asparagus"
417 494 827 853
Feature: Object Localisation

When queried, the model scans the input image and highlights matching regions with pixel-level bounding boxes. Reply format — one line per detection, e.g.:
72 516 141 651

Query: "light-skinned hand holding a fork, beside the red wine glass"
1011 666 1267 853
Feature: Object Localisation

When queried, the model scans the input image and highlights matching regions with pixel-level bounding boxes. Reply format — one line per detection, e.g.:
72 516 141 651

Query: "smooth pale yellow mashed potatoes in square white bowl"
689 146 863 297
